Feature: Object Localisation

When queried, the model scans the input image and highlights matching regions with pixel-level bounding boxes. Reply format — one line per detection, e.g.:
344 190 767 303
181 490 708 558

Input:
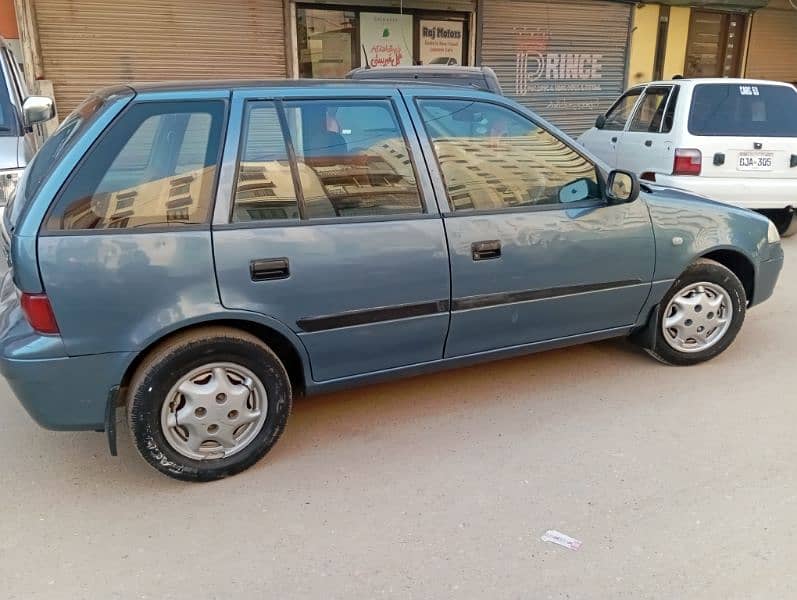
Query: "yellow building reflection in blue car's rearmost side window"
63 165 216 229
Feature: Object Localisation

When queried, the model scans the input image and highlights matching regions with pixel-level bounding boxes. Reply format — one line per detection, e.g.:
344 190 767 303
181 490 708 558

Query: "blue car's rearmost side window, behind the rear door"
47 101 225 231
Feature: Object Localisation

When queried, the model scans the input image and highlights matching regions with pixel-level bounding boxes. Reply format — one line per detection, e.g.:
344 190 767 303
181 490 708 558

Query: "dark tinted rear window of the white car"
689 83 797 137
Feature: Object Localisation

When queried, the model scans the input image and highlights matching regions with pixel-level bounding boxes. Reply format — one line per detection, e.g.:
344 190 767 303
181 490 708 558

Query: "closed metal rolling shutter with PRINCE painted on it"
480 0 632 135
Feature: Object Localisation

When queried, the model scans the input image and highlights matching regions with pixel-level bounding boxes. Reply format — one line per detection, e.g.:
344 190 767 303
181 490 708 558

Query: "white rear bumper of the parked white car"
656 173 797 210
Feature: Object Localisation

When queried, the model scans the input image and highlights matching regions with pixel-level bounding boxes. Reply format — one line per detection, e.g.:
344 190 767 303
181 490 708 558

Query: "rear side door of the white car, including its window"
617 85 677 175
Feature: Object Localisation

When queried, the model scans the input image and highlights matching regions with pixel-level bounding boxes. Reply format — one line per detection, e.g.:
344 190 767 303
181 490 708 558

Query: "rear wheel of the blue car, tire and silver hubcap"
128 327 291 481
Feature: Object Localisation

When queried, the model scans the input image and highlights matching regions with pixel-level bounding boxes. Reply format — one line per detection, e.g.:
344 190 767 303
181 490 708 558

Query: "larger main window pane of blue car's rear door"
285 100 423 219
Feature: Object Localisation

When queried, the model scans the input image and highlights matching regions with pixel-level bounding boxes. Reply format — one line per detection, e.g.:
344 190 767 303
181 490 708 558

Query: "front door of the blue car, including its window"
413 95 654 357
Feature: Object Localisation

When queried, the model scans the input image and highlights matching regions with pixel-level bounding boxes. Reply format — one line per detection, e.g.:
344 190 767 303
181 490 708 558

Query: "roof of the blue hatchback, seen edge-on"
125 79 462 92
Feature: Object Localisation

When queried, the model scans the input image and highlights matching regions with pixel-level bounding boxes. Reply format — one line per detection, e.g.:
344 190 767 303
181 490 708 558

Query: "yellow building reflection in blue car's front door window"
435 130 595 210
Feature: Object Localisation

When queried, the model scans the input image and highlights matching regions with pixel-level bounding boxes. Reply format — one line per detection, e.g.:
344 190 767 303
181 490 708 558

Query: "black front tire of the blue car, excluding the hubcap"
646 258 747 366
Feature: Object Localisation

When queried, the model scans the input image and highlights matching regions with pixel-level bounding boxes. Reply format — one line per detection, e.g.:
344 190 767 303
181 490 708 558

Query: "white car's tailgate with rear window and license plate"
688 82 797 180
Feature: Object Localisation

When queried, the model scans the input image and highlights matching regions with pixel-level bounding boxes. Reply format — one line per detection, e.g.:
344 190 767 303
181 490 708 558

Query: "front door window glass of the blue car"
418 99 600 212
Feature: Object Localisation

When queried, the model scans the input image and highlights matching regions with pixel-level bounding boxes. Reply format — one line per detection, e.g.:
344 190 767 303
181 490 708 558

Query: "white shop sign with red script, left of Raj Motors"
360 12 412 68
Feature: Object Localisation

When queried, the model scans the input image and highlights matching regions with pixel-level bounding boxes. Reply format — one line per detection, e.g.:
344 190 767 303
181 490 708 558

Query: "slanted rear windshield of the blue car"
6 96 108 226
